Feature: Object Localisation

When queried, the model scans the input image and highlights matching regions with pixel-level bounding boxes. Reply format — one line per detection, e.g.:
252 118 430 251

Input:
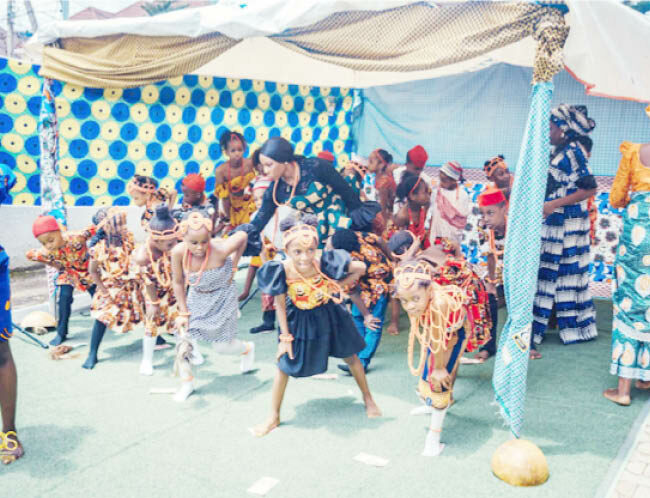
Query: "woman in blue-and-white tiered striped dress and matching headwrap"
530 104 597 358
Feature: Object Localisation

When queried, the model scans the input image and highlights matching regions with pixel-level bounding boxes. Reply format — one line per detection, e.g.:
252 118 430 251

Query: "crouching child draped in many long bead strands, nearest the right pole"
395 243 491 456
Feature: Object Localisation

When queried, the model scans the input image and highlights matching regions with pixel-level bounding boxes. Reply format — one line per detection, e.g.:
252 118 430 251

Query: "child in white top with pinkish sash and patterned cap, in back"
430 161 471 244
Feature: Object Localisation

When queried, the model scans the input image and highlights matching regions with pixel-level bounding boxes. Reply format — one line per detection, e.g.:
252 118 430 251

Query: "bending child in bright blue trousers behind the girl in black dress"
330 229 393 373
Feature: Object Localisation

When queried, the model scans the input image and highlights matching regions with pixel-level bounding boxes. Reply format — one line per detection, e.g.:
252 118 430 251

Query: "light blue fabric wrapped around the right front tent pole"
492 82 553 437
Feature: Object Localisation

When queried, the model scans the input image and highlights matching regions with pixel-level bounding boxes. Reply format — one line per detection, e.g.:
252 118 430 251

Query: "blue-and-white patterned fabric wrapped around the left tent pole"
38 78 67 296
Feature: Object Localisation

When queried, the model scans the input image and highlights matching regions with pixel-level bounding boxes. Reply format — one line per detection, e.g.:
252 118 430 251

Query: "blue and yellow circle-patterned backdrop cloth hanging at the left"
0 60 353 206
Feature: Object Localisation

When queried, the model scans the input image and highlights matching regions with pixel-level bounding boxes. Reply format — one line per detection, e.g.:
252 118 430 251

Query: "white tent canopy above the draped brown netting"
25 0 650 102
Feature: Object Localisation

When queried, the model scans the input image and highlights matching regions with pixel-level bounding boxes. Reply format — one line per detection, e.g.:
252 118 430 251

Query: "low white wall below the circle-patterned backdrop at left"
0 205 145 270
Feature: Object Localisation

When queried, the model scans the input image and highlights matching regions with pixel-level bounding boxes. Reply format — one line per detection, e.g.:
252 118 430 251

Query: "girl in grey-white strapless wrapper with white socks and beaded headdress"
172 212 255 401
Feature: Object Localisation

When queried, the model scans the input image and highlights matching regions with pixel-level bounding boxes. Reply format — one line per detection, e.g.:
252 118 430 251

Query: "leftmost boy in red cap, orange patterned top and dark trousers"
26 216 96 346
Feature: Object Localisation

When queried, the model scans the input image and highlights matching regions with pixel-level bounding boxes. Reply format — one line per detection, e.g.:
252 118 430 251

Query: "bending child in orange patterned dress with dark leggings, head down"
82 207 144 369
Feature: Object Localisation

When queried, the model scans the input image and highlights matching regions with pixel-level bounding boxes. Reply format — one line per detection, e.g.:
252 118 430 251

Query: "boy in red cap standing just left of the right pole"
475 187 508 362
